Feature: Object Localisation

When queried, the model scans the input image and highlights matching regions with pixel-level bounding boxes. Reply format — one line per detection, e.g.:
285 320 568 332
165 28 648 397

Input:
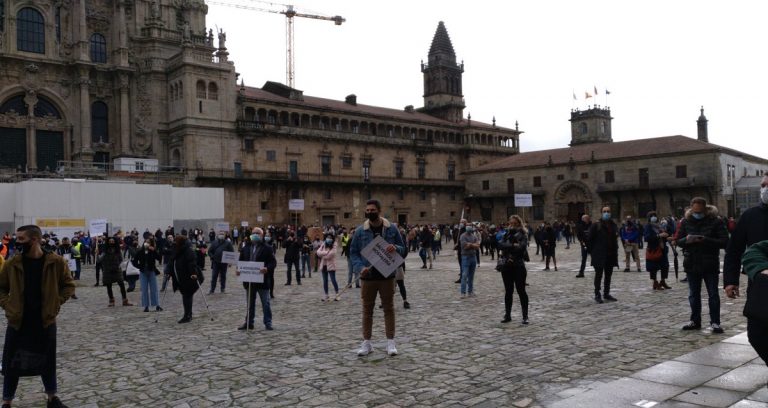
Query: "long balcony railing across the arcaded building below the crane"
196 169 464 187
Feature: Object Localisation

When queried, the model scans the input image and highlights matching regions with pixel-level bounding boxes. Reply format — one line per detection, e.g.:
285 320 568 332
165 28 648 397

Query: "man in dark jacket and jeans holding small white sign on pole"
237 227 277 330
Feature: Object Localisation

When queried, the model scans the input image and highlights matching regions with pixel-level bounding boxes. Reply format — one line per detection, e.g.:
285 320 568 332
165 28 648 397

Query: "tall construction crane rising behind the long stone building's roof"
206 0 347 88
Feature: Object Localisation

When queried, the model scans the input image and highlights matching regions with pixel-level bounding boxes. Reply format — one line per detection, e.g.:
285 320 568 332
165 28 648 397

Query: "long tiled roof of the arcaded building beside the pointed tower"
245 87 515 132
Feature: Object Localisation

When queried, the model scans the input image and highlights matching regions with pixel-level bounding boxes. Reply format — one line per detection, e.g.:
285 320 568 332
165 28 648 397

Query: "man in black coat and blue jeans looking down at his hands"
677 197 728 333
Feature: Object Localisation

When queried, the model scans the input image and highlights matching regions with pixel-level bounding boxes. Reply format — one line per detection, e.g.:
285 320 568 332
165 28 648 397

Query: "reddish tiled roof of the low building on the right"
466 135 768 174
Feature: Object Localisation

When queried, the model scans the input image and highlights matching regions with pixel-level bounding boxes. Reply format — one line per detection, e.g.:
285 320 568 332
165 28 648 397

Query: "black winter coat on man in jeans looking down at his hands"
677 205 728 273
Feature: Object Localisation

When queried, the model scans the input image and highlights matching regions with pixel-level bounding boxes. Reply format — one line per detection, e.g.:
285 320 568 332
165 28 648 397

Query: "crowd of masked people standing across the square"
0 175 768 407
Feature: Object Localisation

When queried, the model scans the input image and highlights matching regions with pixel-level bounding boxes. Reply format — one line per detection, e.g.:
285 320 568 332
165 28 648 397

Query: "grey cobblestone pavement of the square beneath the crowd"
0 245 746 407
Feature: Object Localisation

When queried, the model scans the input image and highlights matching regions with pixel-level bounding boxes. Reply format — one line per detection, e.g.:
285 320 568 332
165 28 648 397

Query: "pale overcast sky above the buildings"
208 0 768 157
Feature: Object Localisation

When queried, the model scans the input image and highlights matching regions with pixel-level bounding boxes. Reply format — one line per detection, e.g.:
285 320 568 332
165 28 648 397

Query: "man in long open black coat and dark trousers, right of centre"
587 206 619 303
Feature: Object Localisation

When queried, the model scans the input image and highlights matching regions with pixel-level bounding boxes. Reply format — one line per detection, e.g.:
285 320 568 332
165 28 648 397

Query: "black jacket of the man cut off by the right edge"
723 204 768 285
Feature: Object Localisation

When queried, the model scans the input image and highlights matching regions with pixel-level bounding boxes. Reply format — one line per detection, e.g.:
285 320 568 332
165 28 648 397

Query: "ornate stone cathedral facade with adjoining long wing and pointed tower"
0 0 522 224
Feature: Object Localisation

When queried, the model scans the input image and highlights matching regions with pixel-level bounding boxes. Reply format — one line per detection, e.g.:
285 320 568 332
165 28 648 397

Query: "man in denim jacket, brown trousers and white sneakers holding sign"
349 200 408 356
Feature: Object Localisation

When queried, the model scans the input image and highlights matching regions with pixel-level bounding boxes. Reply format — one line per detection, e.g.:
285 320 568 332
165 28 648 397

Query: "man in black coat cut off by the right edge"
723 173 768 363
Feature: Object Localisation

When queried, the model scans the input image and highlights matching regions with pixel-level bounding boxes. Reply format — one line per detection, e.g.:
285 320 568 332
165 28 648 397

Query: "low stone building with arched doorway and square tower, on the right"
465 106 768 222
